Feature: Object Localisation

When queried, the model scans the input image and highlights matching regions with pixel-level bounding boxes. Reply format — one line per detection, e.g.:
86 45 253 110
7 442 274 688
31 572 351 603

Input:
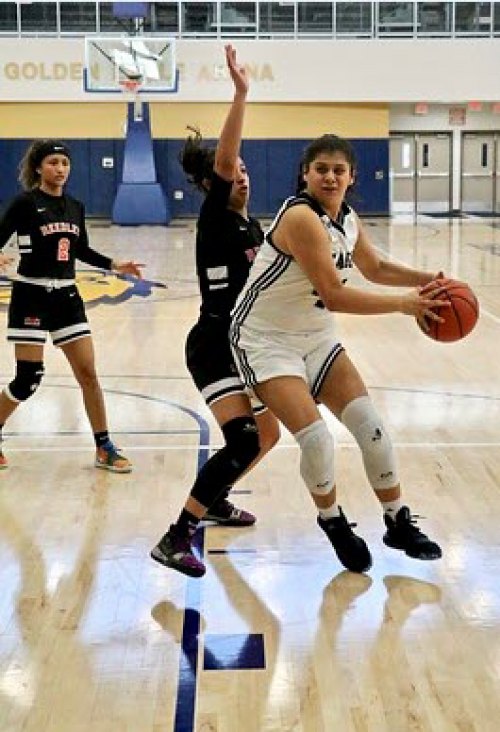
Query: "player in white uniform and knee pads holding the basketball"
230 135 450 572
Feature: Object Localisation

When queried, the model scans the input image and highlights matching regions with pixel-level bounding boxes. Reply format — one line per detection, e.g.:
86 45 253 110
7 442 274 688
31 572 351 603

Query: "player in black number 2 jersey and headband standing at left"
0 140 142 473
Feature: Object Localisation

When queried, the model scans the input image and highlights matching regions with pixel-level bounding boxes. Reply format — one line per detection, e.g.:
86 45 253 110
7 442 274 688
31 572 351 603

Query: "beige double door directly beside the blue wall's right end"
389 132 452 214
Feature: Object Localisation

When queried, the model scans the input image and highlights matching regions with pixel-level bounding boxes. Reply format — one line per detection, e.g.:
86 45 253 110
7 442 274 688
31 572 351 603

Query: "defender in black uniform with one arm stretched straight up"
151 46 279 577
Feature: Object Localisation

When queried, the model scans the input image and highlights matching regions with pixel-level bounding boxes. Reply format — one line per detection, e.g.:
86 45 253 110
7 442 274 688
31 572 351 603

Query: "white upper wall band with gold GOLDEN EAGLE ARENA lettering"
0 38 500 103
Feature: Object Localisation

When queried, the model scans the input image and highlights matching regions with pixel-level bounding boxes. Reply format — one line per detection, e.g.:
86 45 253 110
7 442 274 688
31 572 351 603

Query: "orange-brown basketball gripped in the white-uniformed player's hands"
418 279 479 343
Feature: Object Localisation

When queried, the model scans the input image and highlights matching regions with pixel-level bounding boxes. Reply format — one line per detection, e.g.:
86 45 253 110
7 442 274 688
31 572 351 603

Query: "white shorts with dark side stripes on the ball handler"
230 326 344 406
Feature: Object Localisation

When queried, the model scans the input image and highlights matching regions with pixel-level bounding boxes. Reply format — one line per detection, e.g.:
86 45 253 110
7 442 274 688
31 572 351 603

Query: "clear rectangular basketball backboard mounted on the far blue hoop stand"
83 35 178 94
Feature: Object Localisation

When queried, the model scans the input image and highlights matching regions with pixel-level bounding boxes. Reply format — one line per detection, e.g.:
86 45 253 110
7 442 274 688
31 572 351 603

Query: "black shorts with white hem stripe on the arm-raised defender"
186 317 246 406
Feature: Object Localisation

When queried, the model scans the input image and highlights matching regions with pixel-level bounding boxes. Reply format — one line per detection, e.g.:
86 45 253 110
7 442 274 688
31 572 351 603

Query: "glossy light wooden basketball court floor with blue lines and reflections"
0 217 500 732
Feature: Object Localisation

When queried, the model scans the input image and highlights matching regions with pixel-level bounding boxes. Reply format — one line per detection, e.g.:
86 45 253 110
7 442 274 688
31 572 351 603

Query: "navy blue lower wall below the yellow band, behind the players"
0 139 389 218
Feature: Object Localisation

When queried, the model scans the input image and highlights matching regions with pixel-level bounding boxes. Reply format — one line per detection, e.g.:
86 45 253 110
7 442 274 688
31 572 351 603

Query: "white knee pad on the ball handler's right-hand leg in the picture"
341 396 399 491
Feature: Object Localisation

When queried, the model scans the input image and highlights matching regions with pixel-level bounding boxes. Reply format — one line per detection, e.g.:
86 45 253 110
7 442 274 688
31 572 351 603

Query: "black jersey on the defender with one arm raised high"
196 174 264 320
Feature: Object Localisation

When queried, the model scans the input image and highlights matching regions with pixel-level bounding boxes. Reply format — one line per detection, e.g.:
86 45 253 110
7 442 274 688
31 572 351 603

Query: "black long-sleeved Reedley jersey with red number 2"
0 189 111 280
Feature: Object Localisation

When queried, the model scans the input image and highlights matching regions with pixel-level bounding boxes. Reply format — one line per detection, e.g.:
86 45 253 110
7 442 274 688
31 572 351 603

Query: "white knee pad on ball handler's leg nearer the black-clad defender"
294 419 335 496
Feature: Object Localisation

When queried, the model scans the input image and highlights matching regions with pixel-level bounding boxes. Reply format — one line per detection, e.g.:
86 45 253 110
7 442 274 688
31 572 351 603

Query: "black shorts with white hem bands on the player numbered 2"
7 281 90 346
